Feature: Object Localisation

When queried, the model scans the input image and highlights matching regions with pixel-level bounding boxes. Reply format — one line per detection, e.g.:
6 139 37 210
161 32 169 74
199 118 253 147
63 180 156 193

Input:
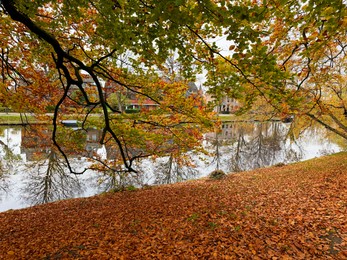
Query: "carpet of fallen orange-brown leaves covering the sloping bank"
0 153 347 259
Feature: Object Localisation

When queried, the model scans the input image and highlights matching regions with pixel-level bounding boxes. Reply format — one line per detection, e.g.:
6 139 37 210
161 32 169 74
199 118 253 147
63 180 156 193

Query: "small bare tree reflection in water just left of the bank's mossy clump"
154 154 198 184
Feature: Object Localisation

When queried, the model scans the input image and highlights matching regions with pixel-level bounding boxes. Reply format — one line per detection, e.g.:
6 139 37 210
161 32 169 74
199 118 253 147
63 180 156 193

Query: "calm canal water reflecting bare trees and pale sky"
0 122 347 211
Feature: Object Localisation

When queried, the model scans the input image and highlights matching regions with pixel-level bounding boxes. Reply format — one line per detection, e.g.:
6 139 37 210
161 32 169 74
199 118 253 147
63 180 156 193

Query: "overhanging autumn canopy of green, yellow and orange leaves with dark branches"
0 0 347 175
